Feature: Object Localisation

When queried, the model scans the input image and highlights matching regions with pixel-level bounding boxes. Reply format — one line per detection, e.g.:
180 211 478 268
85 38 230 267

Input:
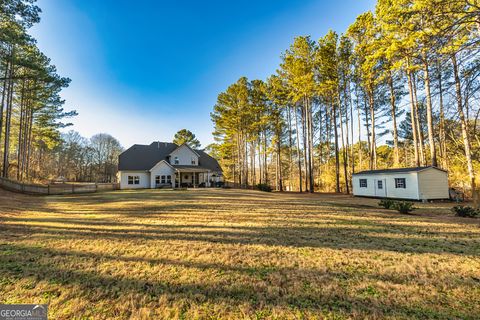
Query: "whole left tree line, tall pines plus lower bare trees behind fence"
0 0 122 182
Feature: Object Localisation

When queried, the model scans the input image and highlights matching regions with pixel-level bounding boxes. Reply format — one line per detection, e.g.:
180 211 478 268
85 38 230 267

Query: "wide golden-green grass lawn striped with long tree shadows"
0 190 480 319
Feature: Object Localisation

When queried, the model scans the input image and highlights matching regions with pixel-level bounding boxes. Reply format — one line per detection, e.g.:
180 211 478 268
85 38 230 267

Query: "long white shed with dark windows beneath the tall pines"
352 167 449 200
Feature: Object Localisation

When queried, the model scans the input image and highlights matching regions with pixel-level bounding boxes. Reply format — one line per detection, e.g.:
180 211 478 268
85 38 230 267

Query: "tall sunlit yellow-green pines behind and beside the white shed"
210 0 480 192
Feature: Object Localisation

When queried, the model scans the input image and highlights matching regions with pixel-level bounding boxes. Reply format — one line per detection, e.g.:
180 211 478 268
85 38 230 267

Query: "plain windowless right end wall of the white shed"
418 168 449 199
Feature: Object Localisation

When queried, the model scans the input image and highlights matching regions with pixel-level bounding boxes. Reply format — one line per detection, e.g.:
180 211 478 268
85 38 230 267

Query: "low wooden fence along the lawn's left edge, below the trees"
0 178 118 195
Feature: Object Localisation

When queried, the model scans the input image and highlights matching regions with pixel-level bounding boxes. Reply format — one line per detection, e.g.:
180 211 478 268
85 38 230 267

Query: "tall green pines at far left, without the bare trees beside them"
0 0 76 180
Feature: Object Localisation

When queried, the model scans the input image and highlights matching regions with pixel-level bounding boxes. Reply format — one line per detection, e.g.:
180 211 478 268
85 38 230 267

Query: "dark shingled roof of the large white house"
118 142 222 171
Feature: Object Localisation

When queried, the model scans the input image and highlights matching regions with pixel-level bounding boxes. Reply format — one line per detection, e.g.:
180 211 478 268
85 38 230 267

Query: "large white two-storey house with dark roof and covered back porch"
118 142 223 189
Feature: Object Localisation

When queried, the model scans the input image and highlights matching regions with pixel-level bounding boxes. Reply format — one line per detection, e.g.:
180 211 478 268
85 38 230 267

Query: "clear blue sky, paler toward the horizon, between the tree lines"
31 0 374 147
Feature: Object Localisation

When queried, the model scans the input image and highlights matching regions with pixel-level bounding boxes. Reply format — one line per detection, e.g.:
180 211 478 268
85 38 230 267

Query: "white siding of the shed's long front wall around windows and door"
352 172 420 200
